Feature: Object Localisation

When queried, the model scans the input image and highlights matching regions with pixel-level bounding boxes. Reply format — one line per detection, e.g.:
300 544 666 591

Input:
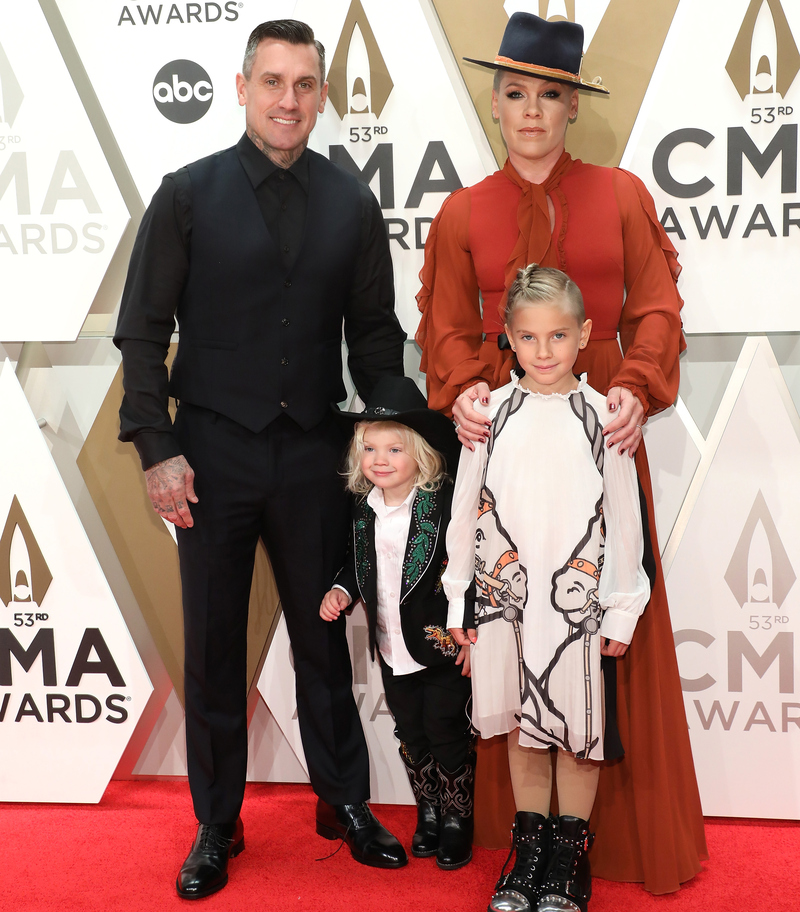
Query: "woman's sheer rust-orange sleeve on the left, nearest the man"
415 188 495 414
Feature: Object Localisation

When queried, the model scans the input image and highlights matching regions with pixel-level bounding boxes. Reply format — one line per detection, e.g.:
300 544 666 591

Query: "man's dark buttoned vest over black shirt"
170 148 361 432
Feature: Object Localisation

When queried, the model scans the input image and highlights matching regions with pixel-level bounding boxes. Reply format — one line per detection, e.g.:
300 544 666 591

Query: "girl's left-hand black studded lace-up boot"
488 811 550 912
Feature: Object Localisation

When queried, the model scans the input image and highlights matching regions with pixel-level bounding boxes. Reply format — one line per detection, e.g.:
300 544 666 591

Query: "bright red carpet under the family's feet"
0 781 800 912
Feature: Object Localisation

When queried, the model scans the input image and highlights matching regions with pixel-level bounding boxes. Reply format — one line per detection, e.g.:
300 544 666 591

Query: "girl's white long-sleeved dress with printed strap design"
443 376 650 760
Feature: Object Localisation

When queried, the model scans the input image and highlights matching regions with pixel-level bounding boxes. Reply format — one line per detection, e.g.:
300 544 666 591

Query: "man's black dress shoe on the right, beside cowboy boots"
317 798 408 868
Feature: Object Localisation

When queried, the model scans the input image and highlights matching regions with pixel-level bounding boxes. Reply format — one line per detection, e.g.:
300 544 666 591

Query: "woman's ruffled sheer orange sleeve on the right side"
609 169 686 415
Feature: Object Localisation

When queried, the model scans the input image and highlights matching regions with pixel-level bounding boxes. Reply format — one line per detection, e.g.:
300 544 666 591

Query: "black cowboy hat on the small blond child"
334 377 461 475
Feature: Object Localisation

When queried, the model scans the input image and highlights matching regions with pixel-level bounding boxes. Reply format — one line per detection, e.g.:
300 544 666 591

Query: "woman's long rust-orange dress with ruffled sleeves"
416 152 708 893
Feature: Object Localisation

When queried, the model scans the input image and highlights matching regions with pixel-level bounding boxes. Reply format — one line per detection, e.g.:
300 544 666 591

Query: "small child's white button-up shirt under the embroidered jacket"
367 488 425 675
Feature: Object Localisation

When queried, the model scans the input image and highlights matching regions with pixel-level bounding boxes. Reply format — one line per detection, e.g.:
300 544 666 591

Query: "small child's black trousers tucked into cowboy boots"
380 657 472 773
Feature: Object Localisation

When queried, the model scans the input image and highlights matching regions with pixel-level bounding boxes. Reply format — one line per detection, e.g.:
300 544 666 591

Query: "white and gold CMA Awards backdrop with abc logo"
0 0 800 818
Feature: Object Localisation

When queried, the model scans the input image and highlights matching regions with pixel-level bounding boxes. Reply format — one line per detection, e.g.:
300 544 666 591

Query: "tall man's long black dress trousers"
175 403 369 823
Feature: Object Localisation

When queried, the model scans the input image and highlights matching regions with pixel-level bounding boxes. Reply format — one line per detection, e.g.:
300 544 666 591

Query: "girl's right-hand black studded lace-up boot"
539 817 594 912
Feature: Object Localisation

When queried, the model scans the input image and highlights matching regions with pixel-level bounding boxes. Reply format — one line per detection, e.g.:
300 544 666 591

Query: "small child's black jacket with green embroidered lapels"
335 481 459 667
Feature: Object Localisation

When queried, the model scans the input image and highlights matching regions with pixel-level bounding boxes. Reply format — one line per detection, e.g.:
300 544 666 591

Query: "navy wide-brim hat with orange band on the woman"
464 13 609 95
